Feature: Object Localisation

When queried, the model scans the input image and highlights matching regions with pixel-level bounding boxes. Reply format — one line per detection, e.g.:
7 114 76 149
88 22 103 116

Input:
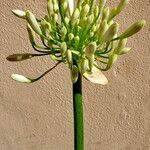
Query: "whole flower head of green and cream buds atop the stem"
7 0 146 85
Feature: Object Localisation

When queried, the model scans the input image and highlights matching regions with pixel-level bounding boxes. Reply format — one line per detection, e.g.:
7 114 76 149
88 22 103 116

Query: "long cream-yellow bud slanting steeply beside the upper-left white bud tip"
26 11 42 35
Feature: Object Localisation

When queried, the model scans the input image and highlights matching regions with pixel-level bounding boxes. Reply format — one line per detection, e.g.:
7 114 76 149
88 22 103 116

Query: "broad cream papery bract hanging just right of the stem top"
83 66 108 85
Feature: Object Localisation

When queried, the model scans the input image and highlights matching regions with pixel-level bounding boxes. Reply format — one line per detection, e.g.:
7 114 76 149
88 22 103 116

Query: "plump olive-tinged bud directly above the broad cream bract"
85 42 97 58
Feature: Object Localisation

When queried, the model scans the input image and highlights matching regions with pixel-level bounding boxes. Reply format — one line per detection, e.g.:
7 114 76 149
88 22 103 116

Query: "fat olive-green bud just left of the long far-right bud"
102 23 119 42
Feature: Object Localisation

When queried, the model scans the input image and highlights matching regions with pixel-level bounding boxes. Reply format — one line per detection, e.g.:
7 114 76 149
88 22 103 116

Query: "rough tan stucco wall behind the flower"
0 0 150 150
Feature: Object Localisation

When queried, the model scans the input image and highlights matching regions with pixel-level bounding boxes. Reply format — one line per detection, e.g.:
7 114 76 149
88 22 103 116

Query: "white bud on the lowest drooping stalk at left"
11 74 32 83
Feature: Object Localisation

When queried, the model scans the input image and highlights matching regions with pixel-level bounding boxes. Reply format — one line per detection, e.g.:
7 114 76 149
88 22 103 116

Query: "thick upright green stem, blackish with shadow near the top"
73 74 84 150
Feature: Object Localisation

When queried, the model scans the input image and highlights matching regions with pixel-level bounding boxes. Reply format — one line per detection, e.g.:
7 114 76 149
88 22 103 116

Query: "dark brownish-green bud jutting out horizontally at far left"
6 53 34 62
